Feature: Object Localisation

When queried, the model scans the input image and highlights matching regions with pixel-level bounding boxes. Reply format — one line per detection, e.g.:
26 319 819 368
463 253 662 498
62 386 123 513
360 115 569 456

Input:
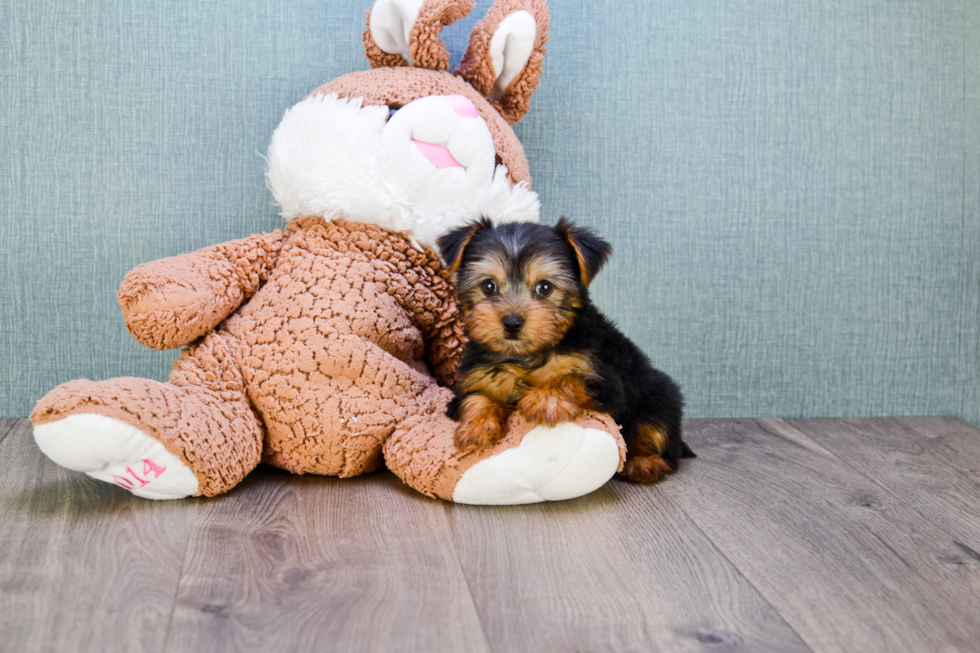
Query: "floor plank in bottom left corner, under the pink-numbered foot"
0 420 196 651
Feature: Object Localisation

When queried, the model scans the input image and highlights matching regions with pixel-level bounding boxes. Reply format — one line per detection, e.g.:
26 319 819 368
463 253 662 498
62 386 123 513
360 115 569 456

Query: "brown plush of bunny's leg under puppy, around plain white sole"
384 412 626 501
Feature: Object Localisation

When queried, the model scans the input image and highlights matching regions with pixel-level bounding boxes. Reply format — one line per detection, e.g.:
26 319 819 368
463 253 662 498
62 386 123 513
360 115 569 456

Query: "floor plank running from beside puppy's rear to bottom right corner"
678 420 980 652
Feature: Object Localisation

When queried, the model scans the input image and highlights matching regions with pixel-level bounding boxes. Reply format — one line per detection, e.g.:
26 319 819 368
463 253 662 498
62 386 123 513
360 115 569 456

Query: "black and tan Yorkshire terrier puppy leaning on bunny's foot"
439 218 694 483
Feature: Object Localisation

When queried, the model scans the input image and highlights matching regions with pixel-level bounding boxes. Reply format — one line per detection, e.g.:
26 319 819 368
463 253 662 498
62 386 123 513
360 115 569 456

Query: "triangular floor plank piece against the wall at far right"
780 418 980 548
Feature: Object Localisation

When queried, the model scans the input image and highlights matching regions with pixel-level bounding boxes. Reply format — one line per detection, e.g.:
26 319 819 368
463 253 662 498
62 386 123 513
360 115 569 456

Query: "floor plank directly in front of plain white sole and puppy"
445 476 809 651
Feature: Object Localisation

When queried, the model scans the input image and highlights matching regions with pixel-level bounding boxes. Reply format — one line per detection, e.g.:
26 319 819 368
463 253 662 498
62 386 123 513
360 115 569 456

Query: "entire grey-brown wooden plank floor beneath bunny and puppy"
0 418 980 653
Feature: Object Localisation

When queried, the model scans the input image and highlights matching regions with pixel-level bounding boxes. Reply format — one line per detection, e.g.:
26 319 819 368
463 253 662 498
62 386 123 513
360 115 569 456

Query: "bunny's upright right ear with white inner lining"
455 0 551 124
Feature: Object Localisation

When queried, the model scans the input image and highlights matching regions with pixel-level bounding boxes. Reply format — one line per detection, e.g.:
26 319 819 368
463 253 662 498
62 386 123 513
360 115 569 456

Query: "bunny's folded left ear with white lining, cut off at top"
363 0 476 70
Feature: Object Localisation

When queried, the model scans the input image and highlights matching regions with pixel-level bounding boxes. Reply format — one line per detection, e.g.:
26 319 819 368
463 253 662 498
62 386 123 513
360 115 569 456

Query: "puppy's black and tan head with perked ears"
439 218 612 356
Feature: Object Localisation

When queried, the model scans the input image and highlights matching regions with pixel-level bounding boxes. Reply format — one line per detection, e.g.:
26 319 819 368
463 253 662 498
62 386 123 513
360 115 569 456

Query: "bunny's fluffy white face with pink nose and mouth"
266 94 539 251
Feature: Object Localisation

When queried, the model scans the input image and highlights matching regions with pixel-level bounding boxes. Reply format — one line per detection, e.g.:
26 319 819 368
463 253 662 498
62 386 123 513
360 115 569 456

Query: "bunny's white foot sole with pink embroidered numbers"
34 413 198 499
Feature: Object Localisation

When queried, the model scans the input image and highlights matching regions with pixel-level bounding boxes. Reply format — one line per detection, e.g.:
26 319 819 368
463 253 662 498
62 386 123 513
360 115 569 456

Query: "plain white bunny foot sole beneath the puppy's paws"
453 423 619 506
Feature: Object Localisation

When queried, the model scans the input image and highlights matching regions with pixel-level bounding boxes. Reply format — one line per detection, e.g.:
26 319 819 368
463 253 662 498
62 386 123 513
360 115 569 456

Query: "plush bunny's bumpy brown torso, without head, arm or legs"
239 218 463 476
